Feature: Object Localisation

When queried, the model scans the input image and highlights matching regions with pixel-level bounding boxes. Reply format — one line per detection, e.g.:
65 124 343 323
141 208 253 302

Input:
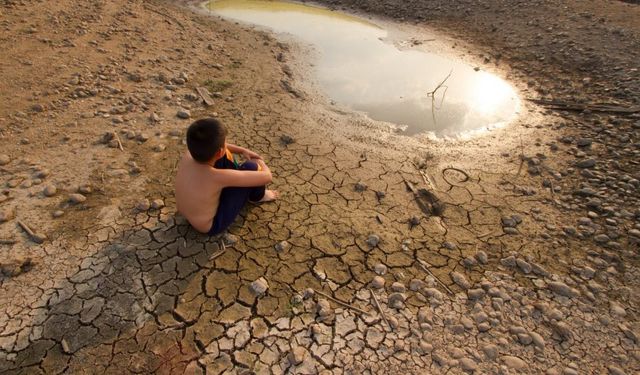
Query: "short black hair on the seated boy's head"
187 118 227 163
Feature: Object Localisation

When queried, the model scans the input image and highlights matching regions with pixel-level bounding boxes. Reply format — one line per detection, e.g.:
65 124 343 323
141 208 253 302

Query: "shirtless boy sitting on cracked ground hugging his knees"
176 118 278 235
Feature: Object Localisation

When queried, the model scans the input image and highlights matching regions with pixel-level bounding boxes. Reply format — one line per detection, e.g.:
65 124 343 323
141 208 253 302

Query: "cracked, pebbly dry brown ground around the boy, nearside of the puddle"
0 0 640 374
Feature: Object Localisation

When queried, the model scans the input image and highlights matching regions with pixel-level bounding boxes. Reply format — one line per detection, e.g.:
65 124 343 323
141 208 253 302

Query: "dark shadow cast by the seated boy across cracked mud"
0 215 228 373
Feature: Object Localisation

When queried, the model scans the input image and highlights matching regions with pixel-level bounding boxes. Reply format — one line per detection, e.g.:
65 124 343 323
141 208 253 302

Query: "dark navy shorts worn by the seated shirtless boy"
209 157 265 236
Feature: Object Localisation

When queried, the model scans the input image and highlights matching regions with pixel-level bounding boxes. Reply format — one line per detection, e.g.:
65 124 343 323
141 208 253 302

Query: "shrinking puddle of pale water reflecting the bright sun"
206 0 519 137
